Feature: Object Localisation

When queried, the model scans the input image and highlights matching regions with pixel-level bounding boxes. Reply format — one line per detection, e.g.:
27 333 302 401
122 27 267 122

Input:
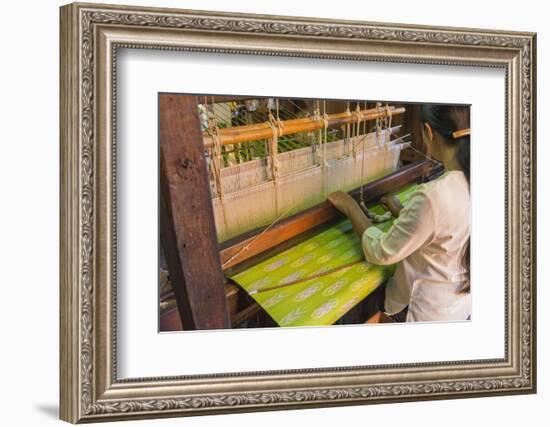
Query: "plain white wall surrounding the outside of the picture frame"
0 0 550 427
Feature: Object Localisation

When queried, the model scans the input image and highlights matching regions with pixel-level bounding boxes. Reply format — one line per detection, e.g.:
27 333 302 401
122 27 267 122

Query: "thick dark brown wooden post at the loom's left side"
159 94 231 329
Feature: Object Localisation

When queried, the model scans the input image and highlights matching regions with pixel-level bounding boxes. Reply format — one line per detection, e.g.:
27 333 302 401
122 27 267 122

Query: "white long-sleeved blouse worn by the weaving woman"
362 171 471 322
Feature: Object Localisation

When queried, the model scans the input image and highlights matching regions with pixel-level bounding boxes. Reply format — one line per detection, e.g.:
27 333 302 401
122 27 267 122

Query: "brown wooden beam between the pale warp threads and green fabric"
220 160 432 270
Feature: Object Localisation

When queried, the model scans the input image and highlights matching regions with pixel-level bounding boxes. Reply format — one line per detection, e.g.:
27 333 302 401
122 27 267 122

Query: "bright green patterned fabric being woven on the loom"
231 185 417 326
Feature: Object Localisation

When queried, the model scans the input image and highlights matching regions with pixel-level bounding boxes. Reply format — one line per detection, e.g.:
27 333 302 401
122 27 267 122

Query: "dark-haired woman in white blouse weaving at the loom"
328 105 470 322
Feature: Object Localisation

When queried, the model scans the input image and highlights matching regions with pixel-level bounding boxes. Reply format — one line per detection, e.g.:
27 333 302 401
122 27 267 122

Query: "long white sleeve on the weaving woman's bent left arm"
362 191 437 265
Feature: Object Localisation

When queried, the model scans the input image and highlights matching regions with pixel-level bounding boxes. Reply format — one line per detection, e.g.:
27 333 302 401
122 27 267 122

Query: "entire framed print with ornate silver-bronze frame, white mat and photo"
60 4 536 423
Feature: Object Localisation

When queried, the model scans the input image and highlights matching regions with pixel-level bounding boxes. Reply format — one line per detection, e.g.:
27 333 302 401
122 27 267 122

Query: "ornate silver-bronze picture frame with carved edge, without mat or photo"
60 4 536 423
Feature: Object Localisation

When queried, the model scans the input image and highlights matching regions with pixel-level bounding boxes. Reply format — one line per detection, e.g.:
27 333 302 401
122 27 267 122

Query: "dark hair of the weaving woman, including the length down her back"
420 104 470 292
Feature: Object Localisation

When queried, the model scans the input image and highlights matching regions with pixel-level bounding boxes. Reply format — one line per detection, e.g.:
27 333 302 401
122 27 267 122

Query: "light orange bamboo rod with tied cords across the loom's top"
203 107 405 147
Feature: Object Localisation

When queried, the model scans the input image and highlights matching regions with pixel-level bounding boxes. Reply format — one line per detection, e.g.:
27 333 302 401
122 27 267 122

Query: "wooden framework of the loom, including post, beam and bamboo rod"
159 95 440 330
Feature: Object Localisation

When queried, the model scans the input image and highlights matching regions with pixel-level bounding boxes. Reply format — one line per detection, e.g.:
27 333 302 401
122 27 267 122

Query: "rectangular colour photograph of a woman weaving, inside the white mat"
159 94 476 332
